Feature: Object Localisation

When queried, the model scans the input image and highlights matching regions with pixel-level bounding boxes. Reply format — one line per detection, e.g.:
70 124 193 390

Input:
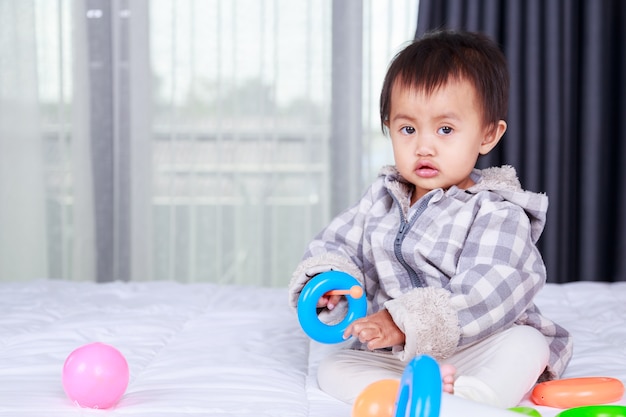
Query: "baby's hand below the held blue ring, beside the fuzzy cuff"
343 310 405 350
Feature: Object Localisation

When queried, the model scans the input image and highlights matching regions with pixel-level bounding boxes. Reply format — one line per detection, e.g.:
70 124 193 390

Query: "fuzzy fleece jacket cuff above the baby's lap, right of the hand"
385 287 461 361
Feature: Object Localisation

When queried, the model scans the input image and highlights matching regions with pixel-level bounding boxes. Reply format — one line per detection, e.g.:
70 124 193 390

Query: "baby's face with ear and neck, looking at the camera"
388 80 506 204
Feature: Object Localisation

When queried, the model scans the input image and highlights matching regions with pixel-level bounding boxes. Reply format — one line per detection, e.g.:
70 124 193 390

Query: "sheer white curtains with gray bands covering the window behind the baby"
0 0 417 286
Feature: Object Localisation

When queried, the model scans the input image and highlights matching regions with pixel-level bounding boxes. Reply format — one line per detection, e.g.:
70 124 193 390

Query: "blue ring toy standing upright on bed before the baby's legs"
395 355 443 417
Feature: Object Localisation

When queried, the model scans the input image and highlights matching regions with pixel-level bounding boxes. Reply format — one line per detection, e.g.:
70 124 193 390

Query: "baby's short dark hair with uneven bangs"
380 30 509 132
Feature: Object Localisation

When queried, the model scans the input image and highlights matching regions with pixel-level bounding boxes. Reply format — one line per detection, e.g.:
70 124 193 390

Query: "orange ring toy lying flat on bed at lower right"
530 377 624 408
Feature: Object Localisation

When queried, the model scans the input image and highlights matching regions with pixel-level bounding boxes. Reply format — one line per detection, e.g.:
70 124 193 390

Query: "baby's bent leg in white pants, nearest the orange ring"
447 326 550 408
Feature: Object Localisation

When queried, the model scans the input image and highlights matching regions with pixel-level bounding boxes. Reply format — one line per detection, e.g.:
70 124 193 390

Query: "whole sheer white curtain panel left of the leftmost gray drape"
0 0 96 281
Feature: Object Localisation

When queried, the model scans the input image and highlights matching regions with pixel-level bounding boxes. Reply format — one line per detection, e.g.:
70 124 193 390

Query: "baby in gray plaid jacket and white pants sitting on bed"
289 31 572 407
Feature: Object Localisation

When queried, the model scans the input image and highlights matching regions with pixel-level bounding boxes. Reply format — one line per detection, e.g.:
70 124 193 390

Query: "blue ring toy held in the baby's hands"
298 271 367 343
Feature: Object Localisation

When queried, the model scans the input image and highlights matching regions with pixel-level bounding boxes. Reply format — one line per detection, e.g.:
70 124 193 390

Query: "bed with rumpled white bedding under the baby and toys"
0 280 626 417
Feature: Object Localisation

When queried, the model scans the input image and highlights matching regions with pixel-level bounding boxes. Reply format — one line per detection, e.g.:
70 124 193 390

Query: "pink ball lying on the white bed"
63 343 129 409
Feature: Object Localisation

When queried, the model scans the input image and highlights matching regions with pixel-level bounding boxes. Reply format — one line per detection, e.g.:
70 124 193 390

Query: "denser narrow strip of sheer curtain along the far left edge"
0 1 47 279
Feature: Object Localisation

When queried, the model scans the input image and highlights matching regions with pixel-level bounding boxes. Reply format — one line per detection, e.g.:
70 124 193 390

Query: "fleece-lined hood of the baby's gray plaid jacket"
380 165 548 243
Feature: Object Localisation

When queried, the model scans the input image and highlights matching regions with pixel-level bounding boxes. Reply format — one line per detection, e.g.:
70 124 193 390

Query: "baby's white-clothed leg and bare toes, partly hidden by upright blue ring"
317 349 456 404
